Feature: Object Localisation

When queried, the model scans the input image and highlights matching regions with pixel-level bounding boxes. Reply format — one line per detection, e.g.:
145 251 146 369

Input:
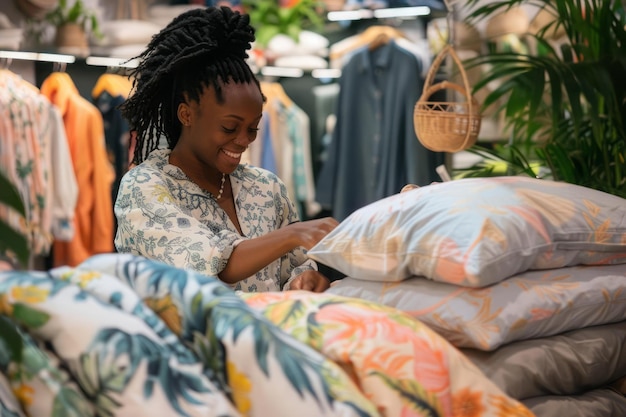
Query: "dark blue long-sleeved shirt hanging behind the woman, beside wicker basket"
315 40 443 221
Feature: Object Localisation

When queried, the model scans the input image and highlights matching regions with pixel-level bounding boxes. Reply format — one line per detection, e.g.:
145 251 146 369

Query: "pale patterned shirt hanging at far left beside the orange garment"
0 70 78 256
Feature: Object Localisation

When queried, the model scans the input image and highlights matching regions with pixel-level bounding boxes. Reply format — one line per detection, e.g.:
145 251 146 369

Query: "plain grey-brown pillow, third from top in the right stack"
461 321 626 398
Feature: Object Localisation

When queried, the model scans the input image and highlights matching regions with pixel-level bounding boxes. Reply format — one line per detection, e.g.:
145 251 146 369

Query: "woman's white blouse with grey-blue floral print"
115 149 317 292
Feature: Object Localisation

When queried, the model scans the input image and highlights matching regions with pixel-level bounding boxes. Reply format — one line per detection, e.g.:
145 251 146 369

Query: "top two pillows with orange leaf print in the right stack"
309 177 626 351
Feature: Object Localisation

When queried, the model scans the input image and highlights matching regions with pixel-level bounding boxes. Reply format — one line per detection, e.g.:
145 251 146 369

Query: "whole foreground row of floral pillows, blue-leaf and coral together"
0 254 532 417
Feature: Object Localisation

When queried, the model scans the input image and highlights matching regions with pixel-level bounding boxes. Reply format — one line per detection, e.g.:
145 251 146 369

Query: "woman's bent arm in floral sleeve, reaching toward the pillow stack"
115 162 337 284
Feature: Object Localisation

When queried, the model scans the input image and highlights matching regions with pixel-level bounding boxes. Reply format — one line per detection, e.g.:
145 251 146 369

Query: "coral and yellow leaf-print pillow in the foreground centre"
240 291 533 417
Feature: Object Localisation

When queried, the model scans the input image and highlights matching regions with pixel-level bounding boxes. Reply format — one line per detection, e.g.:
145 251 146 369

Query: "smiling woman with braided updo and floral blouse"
115 7 337 292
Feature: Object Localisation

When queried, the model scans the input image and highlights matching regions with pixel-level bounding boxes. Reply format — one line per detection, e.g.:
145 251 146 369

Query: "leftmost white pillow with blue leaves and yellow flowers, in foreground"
0 268 240 417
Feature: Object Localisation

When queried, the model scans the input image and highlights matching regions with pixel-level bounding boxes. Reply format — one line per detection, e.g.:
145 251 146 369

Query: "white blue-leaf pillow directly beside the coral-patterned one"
82 255 378 417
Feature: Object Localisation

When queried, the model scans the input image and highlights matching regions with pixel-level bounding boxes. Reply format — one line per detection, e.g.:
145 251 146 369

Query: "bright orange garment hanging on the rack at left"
41 72 115 266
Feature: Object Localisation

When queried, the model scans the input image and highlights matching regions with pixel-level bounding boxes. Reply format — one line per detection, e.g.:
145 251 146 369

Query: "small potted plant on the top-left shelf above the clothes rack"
45 0 102 48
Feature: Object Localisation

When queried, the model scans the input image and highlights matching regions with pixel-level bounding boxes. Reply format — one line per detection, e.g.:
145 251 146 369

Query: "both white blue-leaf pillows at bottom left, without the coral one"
0 254 380 417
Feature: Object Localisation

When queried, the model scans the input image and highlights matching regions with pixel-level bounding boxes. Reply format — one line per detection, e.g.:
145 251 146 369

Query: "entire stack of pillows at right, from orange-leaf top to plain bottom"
308 176 626 417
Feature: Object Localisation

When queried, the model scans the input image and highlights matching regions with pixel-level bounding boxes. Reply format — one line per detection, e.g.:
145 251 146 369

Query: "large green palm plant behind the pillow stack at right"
461 0 626 197
